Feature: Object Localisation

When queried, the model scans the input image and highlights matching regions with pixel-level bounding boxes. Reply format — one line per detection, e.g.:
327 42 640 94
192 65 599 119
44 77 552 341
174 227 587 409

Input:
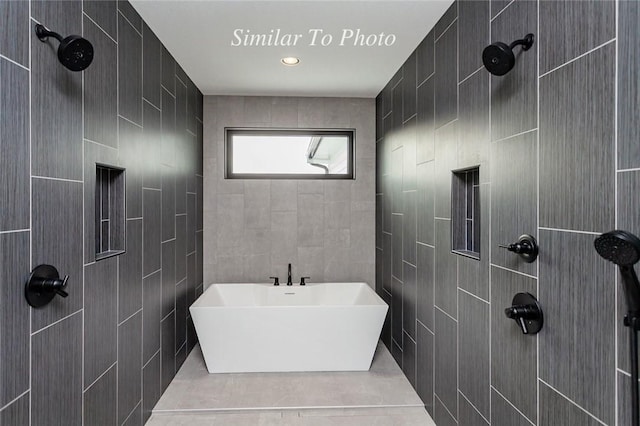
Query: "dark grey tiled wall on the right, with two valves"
376 0 640 426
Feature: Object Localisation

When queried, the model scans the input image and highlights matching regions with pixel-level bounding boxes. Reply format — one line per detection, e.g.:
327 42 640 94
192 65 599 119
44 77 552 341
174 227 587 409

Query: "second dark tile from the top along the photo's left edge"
0 59 29 231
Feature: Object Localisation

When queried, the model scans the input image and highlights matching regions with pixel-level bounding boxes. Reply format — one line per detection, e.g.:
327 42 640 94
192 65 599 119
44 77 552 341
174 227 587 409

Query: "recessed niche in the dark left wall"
95 164 126 260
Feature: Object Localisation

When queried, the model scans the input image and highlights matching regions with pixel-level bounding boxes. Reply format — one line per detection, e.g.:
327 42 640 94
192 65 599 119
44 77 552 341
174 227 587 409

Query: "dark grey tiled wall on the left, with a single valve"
0 0 202 426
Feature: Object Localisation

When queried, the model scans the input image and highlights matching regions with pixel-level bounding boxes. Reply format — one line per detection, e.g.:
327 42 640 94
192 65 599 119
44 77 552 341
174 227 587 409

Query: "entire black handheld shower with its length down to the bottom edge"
593 230 640 426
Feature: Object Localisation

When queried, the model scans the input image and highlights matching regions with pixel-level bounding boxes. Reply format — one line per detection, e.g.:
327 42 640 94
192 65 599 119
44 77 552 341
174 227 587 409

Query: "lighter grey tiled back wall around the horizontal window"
204 96 376 286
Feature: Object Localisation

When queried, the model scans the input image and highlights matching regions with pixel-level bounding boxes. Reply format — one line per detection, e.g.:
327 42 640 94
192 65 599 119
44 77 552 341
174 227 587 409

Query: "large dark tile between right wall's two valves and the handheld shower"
539 231 616 423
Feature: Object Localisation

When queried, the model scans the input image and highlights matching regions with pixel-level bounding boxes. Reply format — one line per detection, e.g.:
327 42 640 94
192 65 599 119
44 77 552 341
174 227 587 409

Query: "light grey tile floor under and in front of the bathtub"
147 344 435 426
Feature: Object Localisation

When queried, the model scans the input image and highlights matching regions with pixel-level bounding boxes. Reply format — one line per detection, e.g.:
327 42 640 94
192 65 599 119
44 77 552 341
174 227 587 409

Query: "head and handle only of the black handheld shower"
593 230 640 314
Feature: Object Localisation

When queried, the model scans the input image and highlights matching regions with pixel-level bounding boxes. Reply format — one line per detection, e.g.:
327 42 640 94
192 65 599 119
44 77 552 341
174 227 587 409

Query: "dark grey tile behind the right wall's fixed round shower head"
490 0 538 140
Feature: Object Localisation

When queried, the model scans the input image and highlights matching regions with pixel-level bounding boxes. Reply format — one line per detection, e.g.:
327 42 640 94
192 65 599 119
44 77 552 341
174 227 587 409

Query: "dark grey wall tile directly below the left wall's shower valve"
31 312 82 426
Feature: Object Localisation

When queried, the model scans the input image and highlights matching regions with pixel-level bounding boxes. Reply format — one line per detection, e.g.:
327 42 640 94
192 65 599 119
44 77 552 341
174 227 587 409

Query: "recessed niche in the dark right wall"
451 167 480 259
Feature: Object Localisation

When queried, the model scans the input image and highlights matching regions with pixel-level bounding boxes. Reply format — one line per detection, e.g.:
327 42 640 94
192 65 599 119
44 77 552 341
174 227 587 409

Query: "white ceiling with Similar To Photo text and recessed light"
131 0 453 98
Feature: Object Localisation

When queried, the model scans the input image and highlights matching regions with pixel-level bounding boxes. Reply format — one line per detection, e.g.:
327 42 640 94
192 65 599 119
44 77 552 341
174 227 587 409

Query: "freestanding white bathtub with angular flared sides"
189 283 388 373
